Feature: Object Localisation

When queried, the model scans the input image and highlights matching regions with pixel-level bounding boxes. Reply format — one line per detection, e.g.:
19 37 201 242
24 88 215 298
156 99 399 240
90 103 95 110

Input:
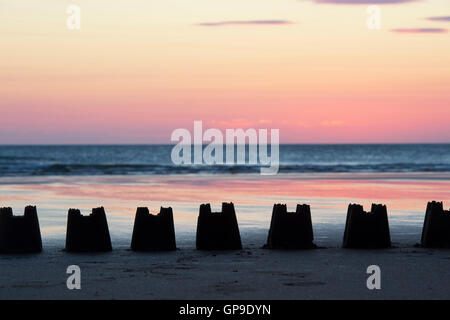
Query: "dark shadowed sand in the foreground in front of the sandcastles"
0 234 450 299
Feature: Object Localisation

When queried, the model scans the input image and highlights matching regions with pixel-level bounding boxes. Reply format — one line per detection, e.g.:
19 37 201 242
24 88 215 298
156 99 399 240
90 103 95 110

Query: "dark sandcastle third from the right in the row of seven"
264 204 316 249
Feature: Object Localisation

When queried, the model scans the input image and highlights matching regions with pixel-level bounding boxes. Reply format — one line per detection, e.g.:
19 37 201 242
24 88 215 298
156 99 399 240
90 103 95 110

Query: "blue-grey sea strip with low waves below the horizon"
0 144 450 177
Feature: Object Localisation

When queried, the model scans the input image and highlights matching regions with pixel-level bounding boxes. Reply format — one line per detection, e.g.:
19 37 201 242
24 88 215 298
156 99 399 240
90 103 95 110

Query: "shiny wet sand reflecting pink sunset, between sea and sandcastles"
0 174 450 244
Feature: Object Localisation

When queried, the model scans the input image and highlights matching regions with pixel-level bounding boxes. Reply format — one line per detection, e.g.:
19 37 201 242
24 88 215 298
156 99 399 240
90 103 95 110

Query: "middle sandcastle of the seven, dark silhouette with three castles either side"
196 202 242 250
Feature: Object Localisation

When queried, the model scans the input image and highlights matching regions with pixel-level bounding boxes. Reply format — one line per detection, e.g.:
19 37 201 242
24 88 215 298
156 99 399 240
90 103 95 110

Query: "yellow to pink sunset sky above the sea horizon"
0 0 450 144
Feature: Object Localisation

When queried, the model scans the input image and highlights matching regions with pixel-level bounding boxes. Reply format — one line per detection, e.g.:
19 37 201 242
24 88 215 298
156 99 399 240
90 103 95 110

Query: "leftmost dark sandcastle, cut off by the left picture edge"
0 206 42 253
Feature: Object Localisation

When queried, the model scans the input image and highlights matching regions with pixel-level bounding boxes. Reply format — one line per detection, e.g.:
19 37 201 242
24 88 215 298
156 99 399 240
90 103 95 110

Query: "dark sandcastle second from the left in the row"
66 207 112 252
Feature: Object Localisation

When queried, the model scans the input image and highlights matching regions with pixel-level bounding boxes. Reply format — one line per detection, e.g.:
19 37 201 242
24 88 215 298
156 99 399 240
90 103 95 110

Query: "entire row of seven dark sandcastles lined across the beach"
0 201 450 253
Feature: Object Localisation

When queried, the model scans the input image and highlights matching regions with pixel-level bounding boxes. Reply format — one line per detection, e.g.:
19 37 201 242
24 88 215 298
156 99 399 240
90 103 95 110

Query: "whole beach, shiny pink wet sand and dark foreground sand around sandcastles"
0 173 450 299
